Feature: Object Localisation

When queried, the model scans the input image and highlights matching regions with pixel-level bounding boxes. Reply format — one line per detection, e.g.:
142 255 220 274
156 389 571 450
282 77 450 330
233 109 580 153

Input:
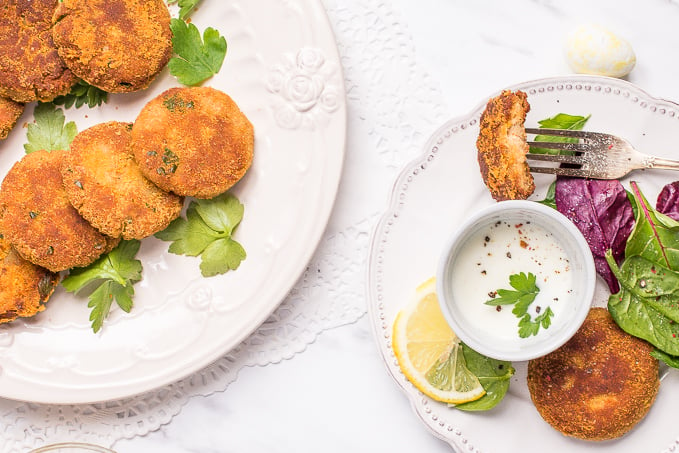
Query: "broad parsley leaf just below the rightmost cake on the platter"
155 193 246 277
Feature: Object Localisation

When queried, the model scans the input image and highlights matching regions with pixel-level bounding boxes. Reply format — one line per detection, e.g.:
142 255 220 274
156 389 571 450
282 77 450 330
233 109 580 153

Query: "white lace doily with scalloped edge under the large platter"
0 0 445 452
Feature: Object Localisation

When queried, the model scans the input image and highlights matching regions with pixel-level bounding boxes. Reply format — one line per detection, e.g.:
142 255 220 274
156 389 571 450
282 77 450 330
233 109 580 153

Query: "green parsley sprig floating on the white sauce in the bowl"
486 272 554 338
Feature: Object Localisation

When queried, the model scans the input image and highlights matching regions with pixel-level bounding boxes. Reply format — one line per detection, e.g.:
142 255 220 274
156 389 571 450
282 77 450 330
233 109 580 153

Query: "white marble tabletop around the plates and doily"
105 0 679 453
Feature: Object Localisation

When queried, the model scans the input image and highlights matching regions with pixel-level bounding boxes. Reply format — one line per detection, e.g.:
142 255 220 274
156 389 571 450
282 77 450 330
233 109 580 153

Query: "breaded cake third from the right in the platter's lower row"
0 151 113 272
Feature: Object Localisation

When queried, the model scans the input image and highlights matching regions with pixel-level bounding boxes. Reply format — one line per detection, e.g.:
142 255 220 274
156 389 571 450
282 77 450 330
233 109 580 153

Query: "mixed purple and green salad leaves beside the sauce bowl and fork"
531 114 679 368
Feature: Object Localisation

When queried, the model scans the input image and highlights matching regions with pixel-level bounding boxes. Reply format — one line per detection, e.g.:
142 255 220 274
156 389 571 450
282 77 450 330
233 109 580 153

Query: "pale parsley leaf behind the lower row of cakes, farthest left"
24 103 78 154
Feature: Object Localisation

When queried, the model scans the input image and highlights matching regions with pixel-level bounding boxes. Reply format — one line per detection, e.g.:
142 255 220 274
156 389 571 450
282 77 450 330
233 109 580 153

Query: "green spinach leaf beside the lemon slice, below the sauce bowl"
455 343 514 412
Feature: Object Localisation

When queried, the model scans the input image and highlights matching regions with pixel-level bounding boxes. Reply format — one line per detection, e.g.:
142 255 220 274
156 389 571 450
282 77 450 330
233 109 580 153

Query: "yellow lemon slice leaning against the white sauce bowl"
392 277 486 404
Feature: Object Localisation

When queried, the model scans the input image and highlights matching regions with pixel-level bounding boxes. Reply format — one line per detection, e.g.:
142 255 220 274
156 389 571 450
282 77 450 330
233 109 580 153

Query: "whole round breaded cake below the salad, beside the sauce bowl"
528 307 660 440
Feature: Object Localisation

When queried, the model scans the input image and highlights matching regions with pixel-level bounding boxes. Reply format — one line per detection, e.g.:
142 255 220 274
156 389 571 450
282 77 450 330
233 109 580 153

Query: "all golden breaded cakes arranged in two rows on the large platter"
0 0 254 323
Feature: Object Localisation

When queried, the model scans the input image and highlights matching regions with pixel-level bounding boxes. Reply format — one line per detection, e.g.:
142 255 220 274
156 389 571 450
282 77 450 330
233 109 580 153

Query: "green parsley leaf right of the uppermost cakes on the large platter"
168 19 226 86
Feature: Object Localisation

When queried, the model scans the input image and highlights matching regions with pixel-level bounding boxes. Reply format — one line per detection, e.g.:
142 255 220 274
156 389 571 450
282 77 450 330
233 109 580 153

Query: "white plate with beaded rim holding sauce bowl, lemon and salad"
368 76 679 453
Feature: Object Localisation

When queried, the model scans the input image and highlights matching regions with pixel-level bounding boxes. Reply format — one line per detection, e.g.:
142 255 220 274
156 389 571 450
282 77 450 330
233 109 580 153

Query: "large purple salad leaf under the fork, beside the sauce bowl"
555 177 634 294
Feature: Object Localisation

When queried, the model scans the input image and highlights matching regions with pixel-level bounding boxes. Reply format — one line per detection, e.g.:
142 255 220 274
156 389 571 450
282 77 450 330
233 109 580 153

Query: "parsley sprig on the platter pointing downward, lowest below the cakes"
61 240 142 333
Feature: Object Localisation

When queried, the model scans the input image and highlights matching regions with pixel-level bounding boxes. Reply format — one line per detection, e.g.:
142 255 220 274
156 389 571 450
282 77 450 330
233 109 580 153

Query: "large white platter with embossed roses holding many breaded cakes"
0 0 346 403
